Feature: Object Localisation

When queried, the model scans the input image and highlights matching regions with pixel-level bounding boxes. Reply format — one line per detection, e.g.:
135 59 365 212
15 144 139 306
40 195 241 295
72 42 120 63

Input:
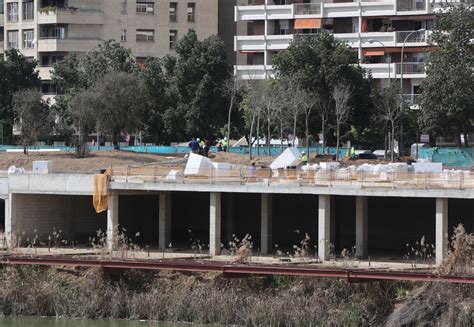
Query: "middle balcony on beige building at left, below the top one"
38 37 102 52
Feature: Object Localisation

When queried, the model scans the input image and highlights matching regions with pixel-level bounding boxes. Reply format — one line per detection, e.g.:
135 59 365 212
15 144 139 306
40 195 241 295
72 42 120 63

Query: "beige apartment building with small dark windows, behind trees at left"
0 0 236 98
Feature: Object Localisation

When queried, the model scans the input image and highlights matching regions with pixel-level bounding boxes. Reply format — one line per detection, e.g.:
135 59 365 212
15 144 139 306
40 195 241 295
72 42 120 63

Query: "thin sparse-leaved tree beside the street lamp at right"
375 83 402 162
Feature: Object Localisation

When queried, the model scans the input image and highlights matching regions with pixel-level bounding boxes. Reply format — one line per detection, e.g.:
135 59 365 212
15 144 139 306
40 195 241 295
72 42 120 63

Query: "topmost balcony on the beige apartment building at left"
38 8 104 25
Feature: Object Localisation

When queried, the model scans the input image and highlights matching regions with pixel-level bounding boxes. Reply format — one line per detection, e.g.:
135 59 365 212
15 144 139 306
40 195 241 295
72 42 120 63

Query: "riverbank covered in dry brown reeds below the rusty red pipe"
1 266 474 326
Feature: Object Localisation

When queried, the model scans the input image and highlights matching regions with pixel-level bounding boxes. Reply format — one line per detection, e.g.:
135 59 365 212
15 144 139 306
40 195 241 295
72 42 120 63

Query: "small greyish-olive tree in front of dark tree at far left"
13 90 53 154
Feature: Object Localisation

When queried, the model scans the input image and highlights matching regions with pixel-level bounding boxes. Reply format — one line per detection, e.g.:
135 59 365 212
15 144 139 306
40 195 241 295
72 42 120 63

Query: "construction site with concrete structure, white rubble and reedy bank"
0 148 474 326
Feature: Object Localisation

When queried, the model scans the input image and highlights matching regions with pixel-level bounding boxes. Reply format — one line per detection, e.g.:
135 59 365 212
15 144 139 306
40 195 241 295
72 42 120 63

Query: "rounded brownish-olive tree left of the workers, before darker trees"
90 72 149 145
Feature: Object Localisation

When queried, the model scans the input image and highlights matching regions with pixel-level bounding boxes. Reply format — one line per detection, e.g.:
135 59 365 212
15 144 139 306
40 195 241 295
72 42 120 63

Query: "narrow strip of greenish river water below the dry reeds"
0 317 196 327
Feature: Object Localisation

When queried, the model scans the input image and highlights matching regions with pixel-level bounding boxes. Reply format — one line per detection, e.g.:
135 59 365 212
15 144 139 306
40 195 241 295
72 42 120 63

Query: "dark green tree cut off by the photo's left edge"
0 49 40 142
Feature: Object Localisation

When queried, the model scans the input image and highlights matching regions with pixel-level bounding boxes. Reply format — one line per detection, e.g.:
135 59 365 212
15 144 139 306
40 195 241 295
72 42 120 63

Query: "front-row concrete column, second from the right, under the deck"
318 194 331 261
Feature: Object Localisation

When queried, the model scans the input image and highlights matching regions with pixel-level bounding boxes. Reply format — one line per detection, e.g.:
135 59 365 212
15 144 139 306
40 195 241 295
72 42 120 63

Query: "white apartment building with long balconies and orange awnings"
234 0 454 103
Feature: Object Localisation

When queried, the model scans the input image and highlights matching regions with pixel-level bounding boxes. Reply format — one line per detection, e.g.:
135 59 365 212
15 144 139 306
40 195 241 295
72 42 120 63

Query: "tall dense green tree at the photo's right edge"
420 3 474 145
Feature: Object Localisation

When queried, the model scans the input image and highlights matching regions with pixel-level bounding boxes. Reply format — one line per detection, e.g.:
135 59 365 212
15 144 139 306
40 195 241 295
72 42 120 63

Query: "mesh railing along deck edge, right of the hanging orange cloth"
111 165 474 190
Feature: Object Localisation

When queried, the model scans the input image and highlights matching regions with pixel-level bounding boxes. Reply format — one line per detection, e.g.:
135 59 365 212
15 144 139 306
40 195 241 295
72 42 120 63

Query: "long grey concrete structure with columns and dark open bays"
0 173 474 263
